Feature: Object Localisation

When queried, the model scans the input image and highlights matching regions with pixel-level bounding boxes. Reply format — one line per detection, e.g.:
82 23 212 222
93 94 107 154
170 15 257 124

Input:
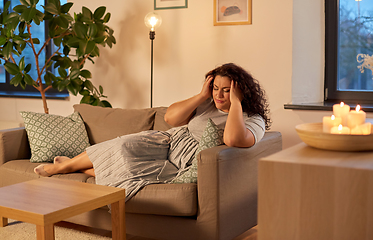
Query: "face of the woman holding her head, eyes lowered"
212 75 231 112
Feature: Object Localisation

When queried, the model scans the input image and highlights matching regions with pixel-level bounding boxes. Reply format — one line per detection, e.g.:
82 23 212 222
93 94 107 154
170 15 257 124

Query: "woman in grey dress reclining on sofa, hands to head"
34 63 270 200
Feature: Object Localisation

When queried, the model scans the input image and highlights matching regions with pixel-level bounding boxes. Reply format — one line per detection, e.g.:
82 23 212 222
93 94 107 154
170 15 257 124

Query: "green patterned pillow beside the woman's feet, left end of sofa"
20 111 90 162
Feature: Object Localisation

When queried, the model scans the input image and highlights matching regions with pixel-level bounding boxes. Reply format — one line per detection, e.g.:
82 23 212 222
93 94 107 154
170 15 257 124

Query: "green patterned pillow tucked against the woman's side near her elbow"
171 118 224 183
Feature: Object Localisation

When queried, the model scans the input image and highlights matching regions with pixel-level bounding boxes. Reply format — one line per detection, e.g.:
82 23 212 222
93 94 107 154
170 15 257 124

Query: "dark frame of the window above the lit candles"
324 0 373 103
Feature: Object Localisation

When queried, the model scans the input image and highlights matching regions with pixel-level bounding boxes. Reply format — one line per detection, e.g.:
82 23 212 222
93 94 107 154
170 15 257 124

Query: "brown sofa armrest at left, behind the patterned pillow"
0 127 31 165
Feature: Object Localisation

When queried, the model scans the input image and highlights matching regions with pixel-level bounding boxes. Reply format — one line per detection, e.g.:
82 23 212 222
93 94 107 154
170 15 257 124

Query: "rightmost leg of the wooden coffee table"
111 199 126 240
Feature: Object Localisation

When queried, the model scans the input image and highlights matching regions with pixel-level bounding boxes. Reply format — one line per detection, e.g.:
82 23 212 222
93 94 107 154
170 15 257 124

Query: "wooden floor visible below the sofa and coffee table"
56 222 258 240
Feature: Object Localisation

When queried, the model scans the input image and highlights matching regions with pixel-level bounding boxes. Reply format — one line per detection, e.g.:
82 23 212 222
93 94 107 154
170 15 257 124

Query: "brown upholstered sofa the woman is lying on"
0 104 282 240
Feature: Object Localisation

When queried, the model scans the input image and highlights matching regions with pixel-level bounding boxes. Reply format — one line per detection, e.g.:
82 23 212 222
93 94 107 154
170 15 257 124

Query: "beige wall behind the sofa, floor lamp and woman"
0 0 368 148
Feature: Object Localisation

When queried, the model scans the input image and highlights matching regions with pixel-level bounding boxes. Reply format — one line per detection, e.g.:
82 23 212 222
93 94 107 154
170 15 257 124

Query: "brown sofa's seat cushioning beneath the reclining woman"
0 159 197 216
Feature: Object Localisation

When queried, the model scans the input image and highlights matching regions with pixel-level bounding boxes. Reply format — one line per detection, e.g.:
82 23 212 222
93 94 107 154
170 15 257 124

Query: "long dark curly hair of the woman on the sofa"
206 63 271 130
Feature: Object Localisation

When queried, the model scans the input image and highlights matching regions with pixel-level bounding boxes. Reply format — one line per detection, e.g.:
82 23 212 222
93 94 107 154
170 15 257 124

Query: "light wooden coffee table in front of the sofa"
0 178 126 240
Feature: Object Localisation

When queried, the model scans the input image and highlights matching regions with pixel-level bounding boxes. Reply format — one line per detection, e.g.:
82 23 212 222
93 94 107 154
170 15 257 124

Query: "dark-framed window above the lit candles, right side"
325 0 373 103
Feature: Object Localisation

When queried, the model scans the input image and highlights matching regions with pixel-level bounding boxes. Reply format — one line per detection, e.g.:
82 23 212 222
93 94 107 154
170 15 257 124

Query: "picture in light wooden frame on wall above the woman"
213 0 252 26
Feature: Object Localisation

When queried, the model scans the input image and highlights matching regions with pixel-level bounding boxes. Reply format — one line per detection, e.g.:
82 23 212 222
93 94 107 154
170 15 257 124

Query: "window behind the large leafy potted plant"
0 0 69 98
